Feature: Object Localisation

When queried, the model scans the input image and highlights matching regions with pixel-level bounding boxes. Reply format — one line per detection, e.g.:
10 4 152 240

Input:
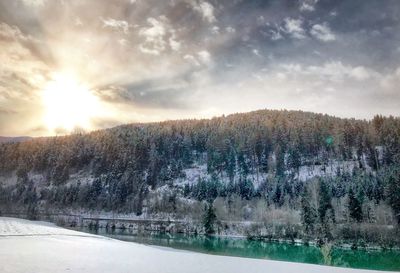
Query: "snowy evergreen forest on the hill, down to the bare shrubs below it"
0 110 400 243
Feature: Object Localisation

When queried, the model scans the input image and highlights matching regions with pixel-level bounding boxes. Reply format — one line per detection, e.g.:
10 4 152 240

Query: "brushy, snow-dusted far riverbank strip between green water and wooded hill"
2 211 400 251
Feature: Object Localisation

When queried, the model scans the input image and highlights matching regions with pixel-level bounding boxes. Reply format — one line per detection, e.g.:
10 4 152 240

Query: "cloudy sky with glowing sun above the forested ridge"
0 0 400 136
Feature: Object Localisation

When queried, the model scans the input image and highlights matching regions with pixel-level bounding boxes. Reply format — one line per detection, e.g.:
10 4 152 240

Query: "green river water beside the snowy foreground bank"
76 229 400 271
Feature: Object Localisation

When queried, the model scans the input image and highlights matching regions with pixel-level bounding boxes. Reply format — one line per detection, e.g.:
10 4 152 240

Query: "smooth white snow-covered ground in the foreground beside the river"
0 217 388 273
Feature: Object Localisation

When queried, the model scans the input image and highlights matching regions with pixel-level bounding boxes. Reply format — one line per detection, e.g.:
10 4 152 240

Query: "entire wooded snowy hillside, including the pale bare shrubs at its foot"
0 110 400 244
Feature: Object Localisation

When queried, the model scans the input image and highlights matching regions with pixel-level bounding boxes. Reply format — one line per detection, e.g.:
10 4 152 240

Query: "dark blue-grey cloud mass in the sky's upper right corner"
206 0 400 69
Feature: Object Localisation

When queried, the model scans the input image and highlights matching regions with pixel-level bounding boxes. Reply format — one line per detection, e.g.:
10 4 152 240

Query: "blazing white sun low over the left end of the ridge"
42 71 100 133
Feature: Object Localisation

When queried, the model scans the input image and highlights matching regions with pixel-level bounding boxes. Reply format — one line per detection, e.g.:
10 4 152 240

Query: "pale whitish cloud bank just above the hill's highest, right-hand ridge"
203 61 400 118
